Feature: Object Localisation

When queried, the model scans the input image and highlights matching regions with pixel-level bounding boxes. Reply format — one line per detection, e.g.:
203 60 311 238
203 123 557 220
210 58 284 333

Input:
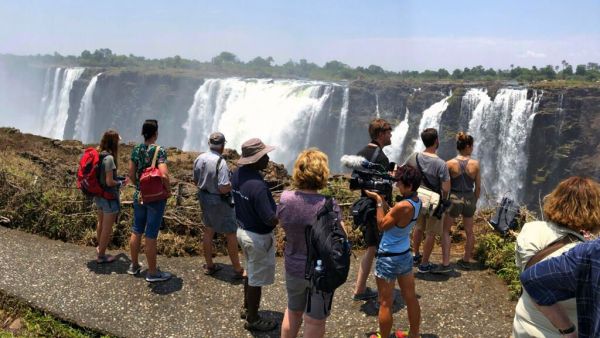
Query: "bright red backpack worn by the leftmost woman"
77 147 117 200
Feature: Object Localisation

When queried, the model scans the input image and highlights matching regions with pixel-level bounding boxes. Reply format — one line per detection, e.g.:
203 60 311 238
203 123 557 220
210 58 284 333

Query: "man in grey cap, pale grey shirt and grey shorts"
194 132 244 279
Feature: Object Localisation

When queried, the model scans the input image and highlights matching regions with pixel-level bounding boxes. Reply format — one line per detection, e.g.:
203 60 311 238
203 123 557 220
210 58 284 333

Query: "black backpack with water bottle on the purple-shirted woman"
305 198 350 292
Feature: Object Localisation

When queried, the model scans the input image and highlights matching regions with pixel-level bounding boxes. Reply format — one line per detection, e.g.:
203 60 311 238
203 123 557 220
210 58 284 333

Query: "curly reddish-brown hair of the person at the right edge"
544 176 600 232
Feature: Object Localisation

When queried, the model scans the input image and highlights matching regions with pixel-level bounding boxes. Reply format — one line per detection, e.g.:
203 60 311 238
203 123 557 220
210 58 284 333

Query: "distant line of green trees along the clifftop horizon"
0 48 600 84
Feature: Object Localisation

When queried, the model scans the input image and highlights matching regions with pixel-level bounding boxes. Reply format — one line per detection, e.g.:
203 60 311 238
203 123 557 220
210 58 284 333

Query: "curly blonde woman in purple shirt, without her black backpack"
277 148 341 338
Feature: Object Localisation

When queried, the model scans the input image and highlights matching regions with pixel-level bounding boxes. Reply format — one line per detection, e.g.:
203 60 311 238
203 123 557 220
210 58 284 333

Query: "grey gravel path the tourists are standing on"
0 227 515 337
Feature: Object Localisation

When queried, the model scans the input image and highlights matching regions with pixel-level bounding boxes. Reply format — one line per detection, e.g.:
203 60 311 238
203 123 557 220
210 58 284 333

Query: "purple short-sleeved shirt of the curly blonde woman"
277 190 340 278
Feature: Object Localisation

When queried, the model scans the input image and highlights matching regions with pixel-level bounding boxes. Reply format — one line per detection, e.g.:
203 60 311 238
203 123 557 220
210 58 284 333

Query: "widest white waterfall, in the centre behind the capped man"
183 78 347 168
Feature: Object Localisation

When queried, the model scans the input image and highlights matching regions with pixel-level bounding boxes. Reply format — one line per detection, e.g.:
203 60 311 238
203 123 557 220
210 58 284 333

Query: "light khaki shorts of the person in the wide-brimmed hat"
237 228 275 286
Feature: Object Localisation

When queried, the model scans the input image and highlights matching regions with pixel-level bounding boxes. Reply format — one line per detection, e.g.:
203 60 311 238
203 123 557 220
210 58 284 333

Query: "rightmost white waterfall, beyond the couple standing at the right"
463 88 538 201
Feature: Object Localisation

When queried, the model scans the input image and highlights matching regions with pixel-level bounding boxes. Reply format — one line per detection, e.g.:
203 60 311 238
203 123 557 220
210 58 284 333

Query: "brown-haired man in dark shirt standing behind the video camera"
352 118 392 300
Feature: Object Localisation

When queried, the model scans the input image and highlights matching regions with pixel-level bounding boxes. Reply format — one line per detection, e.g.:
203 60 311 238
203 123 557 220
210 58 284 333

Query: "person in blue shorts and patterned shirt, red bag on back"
127 120 171 283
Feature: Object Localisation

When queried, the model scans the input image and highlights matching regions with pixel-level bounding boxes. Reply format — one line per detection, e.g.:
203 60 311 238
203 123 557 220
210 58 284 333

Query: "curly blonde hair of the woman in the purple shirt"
292 148 329 190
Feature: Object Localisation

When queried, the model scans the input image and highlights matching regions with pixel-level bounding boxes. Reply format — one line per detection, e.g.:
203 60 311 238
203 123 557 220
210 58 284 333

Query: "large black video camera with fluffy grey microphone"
340 155 396 204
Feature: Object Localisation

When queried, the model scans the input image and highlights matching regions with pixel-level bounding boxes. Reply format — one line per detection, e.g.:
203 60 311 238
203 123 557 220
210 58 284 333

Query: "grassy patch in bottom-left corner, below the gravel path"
0 292 111 338
